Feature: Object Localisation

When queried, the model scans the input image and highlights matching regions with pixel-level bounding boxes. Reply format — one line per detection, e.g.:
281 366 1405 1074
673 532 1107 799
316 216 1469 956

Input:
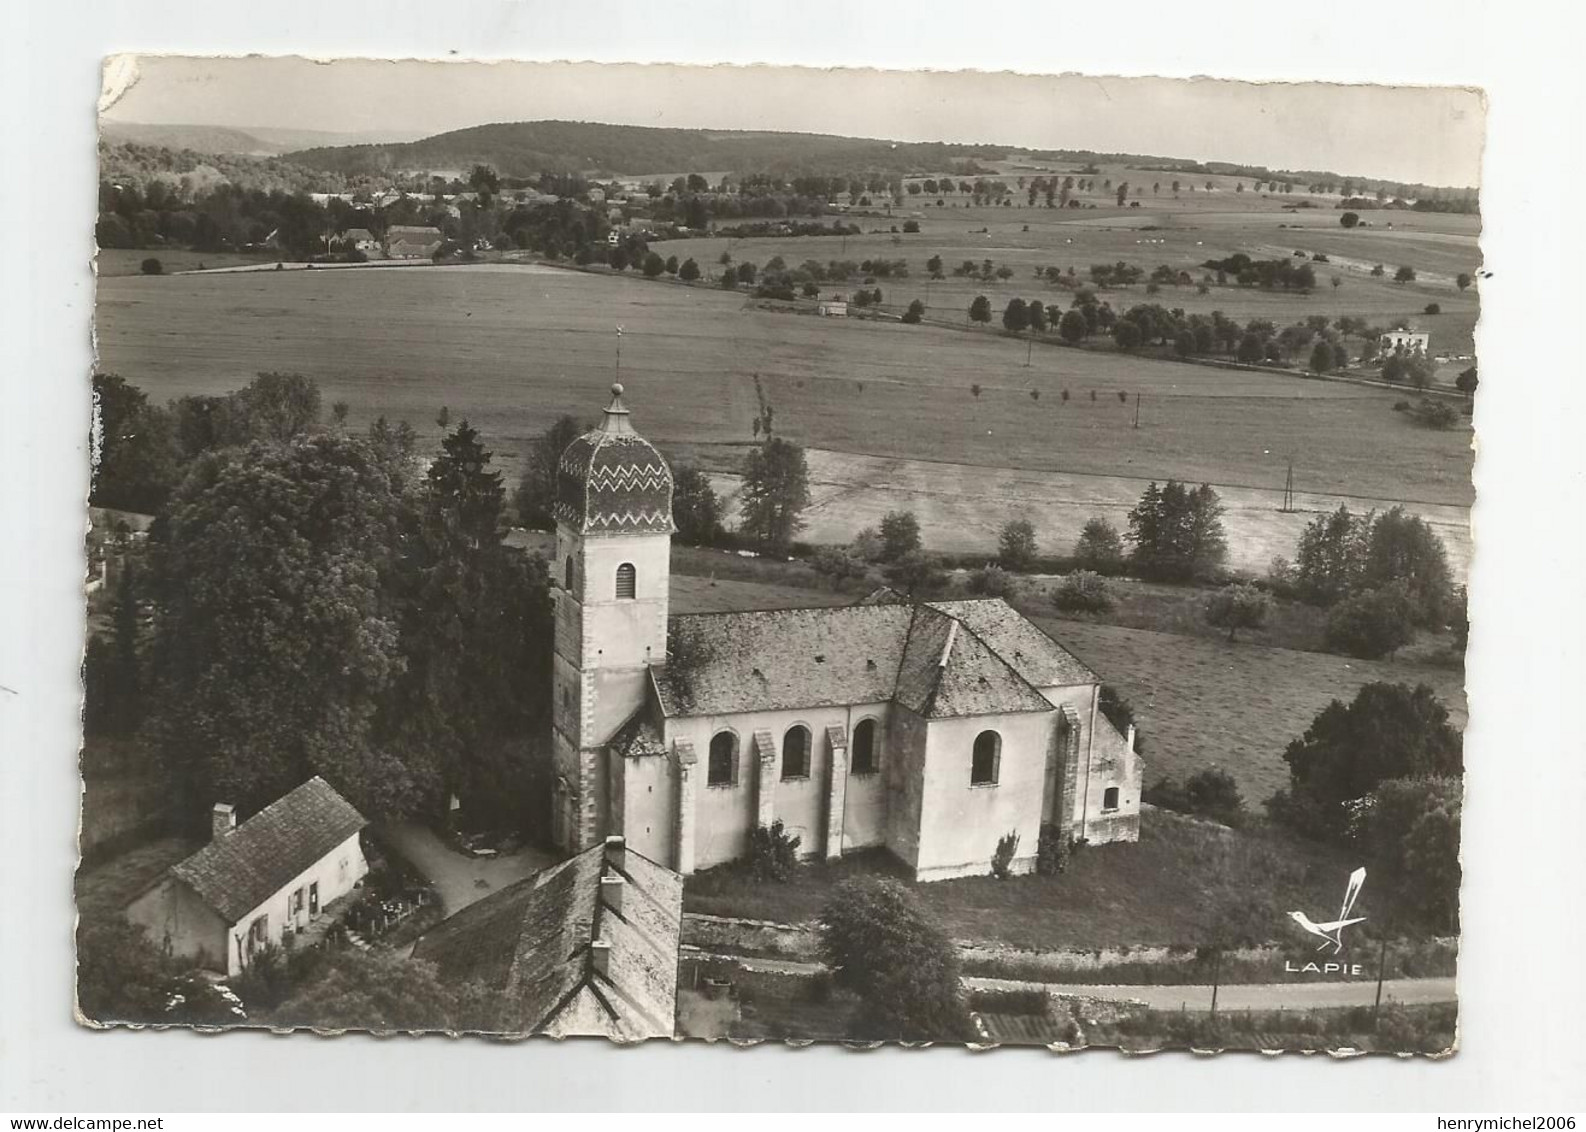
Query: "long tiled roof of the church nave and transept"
652 598 1098 718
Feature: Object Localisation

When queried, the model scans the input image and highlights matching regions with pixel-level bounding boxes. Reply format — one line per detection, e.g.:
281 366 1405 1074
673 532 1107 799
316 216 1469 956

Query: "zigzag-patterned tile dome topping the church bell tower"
555 385 676 534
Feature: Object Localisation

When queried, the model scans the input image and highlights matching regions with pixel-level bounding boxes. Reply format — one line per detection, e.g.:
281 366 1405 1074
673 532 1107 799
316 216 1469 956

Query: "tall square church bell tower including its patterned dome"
550 385 674 851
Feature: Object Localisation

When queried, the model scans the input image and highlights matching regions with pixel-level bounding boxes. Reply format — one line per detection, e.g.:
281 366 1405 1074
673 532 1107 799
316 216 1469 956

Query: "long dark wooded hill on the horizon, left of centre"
279 122 1023 178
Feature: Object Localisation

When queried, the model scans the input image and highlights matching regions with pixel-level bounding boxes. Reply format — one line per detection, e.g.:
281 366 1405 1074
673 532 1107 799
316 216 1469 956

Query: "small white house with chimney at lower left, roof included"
127 777 370 975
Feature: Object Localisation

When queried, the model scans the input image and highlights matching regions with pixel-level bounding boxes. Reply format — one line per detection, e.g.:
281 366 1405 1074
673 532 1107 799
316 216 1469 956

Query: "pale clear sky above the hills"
100 55 1486 185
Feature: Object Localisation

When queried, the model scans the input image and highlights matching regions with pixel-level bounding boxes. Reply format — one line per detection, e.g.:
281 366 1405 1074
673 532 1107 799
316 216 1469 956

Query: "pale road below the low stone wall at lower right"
964 977 1456 1010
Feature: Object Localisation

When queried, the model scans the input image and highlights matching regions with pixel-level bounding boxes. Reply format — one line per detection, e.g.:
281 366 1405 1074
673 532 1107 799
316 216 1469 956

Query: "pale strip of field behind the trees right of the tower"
711 449 1473 582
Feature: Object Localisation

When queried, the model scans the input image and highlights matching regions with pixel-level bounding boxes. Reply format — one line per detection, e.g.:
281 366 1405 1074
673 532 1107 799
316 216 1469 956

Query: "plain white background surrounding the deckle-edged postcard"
0 0 1586 1115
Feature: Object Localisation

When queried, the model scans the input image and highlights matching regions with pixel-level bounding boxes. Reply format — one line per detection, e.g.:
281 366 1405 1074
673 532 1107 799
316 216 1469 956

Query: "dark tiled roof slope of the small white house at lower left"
171 777 368 924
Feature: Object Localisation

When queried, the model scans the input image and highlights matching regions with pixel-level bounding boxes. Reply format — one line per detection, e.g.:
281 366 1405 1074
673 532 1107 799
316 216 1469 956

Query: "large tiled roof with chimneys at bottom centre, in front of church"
414 845 684 1040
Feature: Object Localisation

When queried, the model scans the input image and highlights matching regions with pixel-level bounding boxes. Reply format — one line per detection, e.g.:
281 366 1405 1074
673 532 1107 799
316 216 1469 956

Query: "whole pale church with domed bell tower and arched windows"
552 385 1144 880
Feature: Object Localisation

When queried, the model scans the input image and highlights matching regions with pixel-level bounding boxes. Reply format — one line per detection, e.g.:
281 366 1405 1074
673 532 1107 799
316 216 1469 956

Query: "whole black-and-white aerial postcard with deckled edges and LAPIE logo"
76 55 1484 1056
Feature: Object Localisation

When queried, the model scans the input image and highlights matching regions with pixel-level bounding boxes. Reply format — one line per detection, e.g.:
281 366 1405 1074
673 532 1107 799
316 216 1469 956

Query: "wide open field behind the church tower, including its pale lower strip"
98 248 1472 568
